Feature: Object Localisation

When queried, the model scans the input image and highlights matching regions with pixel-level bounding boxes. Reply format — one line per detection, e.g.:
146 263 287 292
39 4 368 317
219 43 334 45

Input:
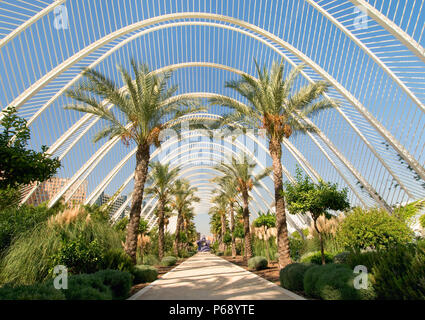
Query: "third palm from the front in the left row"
171 179 201 256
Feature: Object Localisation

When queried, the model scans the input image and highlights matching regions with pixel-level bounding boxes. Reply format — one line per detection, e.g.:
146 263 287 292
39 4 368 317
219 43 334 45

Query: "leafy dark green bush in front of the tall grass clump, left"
52 235 102 274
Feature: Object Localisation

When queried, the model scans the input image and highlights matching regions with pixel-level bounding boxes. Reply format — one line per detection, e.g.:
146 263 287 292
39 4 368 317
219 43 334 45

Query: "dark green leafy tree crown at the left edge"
0 107 60 189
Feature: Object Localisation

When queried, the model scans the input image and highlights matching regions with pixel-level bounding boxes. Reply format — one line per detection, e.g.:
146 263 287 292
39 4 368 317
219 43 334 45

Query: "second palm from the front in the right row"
215 153 271 259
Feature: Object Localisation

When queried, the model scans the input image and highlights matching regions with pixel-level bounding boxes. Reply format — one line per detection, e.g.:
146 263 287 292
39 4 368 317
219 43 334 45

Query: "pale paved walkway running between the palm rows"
130 252 304 300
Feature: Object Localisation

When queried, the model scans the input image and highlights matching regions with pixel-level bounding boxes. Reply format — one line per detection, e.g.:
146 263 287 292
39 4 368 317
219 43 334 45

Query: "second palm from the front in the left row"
146 162 180 260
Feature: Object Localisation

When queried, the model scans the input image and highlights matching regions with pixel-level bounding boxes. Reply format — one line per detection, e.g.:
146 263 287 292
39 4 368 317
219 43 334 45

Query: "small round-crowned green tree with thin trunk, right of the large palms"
284 168 350 264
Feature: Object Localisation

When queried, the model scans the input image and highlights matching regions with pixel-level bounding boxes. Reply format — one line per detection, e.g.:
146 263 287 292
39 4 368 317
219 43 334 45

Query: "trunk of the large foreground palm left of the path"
124 144 150 264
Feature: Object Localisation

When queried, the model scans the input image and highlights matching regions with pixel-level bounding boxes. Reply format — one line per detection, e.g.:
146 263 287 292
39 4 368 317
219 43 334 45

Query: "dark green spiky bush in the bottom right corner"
372 244 425 300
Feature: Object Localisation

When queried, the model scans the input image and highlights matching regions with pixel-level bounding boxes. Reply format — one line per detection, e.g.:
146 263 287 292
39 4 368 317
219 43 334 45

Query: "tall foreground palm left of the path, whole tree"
66 60 201 263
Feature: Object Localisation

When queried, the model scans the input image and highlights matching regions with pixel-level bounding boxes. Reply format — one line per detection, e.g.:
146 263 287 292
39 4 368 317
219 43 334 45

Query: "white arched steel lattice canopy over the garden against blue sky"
0 0 425 234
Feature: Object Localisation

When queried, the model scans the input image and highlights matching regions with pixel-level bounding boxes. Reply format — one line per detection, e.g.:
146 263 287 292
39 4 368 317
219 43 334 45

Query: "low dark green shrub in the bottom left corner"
0 283 65 300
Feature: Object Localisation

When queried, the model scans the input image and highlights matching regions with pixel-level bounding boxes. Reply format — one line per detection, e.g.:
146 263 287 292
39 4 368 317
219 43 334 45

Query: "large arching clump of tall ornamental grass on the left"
0 210 121 285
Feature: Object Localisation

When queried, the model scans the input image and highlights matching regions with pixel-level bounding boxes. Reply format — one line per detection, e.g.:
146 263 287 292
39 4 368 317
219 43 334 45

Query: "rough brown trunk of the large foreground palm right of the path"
269 139 292 269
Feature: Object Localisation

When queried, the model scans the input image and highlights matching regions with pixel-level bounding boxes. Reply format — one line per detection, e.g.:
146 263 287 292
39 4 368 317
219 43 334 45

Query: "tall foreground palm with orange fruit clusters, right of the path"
210 61 337 268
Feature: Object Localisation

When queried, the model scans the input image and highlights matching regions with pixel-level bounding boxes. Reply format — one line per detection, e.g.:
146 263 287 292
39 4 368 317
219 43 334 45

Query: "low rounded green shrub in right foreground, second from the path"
304 264 375 300
